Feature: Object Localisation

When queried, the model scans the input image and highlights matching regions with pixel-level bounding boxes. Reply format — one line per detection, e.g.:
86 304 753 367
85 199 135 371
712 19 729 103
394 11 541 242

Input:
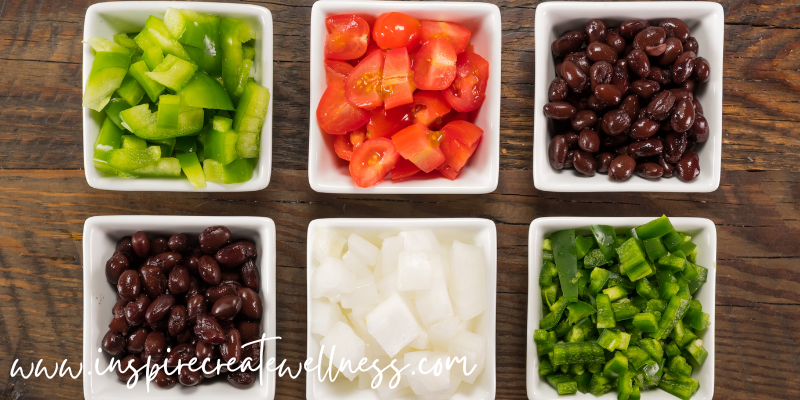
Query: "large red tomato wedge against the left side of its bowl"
317 78 370 135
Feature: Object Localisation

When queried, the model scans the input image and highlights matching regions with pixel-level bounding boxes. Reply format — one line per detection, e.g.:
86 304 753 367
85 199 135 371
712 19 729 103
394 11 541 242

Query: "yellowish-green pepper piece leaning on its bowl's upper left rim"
83 51 131 111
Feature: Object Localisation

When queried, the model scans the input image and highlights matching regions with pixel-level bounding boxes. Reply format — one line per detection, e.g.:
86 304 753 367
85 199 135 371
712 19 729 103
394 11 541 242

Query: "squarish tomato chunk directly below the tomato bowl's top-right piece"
414 38 456 90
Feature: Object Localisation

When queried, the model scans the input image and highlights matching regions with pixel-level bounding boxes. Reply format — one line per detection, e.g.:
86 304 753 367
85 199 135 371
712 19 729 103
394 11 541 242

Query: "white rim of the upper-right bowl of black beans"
532 1 725 193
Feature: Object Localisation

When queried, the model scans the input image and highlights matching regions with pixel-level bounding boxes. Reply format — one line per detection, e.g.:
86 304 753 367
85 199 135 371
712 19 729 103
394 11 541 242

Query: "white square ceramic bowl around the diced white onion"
306 218 497 400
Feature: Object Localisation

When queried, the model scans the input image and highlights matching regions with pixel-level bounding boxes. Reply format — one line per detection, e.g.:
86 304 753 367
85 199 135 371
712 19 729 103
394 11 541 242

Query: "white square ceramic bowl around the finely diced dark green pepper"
525 217 717 400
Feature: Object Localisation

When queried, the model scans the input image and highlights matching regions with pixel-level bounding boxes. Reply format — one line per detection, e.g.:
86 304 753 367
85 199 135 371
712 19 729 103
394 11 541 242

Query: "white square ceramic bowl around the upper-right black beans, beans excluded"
533 1 725 192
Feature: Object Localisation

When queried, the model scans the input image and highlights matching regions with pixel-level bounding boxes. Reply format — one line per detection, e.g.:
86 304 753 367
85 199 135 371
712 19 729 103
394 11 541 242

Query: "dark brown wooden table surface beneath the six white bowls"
0 0 800 399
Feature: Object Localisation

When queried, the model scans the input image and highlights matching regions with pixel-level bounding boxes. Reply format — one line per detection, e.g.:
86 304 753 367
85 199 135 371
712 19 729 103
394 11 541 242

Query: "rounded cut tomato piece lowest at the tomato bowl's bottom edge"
350 138 400 188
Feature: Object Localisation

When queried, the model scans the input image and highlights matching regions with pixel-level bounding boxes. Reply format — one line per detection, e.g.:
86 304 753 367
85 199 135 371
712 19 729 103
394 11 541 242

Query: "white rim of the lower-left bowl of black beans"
81 215 277 400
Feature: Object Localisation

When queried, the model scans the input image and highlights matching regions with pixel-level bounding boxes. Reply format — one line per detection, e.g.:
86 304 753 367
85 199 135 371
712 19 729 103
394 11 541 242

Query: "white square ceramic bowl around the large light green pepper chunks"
83 1 275 192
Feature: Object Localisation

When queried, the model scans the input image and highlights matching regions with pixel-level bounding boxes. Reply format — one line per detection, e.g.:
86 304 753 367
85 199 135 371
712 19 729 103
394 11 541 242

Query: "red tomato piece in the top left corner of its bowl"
325 14 369 60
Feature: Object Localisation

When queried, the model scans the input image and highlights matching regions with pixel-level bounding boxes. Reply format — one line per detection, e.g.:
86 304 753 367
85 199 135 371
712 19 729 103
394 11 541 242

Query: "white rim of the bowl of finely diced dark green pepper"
525 217 717 400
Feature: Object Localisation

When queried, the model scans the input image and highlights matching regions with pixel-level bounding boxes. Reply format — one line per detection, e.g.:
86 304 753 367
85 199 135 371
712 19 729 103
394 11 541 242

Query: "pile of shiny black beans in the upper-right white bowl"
544 18 710 182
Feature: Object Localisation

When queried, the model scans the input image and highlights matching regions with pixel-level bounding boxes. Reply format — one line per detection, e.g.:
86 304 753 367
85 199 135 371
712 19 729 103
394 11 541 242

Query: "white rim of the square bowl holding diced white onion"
306 218 498 400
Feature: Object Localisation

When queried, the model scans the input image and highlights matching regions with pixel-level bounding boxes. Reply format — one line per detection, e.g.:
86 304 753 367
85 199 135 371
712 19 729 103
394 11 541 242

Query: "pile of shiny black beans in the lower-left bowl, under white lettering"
101 226 263 388
